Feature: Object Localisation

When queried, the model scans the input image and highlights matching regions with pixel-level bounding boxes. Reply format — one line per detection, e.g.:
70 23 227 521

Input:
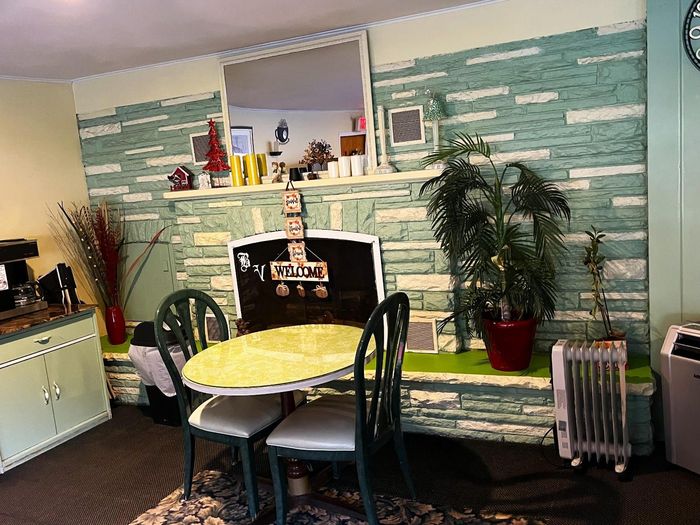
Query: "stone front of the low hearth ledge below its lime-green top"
105 354 654 455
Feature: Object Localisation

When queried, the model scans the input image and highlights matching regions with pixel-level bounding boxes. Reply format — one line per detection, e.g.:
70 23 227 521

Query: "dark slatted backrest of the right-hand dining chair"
354 292 410 451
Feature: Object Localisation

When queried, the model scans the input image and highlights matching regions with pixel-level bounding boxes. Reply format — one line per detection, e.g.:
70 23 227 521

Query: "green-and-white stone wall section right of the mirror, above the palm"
372 22 649 353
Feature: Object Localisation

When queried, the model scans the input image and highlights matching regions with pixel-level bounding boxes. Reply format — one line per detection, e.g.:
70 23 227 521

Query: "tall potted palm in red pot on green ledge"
421 133 570 371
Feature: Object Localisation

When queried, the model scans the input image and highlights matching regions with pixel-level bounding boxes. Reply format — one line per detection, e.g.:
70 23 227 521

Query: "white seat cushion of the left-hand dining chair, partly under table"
189 391 305 438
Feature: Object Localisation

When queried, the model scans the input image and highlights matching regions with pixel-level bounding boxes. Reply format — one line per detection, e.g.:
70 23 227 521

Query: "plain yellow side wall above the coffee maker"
0 80 88 276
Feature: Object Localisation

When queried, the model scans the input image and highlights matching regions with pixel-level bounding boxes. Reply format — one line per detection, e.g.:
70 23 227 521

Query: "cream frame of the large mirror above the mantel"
219 31 377 174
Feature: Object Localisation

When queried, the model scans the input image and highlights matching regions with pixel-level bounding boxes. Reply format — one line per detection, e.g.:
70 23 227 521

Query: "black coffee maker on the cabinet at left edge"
0 239 48 320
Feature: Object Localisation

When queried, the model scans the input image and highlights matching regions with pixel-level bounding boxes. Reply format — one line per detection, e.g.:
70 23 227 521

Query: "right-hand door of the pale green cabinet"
44 338 107 434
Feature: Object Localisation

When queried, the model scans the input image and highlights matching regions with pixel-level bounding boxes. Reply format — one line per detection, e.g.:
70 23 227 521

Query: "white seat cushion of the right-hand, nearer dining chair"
267 396 355 452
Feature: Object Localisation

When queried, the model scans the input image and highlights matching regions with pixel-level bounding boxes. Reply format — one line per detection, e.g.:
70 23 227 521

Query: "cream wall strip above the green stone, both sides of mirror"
73 0 646 113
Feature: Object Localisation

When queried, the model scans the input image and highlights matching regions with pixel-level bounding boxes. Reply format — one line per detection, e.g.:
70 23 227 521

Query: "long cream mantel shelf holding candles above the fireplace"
163 170 440 200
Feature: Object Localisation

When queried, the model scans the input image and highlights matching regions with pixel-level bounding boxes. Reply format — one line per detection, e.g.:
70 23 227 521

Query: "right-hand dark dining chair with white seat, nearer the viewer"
267 292 415 525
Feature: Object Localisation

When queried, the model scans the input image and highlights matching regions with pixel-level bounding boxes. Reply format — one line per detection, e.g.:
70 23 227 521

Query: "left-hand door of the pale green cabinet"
0 356 56 459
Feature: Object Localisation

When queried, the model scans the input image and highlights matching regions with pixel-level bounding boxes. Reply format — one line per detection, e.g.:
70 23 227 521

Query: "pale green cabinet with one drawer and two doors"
0 311 111 472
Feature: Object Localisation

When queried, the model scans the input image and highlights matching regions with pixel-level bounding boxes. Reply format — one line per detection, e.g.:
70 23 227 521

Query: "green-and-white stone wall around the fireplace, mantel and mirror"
78 23 649 353
